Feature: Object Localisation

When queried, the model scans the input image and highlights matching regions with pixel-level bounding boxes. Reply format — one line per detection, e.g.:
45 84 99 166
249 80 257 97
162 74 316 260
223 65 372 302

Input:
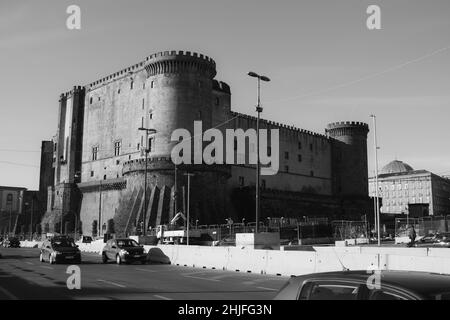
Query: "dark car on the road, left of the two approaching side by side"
39 236 81 264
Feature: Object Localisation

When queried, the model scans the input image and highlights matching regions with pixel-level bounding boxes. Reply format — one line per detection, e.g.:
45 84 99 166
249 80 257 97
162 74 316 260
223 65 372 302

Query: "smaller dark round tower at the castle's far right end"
326 121 369 197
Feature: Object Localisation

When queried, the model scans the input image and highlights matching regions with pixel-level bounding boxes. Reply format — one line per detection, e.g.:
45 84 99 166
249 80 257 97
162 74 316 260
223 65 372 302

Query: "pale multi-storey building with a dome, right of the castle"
369 160 450 217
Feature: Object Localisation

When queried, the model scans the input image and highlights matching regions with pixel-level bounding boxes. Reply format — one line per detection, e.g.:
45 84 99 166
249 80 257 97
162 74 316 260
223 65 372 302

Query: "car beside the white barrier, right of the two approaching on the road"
102 238 147 264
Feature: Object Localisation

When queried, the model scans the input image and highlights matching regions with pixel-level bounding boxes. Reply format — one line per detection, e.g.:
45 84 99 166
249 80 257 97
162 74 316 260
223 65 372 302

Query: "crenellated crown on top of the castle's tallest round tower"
145 51 217 80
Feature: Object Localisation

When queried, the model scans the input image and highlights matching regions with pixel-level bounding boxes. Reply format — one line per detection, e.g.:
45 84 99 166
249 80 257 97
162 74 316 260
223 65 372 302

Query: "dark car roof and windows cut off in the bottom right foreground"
275 270 450 300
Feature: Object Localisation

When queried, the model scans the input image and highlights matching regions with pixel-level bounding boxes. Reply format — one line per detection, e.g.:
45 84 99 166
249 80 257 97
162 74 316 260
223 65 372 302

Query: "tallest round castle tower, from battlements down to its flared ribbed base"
118 51 230 227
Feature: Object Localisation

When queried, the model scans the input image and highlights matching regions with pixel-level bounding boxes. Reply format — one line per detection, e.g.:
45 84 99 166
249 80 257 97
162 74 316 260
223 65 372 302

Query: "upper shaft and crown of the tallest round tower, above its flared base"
145 51 216 157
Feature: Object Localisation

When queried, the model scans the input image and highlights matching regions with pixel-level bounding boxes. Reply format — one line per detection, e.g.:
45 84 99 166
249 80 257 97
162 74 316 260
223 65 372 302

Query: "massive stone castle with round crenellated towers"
42 51 372 235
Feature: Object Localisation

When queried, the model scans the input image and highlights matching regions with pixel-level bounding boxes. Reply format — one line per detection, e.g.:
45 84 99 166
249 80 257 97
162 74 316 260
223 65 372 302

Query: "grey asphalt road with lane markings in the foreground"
0 248 288 300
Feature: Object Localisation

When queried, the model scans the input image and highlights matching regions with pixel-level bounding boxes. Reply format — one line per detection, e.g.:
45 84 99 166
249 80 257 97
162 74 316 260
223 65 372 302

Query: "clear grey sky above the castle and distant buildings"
0 0 450 189
